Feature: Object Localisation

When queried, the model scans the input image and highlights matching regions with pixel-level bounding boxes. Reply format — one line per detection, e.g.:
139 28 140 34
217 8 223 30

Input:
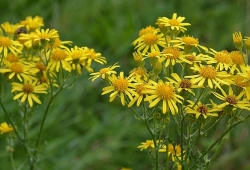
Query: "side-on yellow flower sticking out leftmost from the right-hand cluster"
90 63 120 81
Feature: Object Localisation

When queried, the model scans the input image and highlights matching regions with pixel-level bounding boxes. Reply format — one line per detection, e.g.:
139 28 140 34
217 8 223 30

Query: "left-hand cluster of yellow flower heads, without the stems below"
0 16 106 107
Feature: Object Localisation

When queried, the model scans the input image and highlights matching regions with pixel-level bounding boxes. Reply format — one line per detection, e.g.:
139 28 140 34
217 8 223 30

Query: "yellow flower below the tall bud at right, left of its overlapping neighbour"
207 49 232 71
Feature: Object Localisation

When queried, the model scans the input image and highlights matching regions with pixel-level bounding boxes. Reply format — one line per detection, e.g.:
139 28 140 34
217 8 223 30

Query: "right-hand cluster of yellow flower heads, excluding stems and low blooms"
91 13 250 118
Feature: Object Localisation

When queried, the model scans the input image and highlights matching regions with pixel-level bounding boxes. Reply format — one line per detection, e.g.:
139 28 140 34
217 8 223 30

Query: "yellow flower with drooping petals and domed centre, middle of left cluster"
47 48 71 72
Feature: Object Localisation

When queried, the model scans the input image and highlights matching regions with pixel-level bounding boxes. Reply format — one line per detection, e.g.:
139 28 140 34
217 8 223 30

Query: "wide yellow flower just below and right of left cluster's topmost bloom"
34 29 59 44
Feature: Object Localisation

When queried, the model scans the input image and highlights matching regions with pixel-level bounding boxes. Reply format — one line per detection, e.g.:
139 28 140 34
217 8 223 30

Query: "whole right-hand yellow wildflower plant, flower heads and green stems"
91 13 250 170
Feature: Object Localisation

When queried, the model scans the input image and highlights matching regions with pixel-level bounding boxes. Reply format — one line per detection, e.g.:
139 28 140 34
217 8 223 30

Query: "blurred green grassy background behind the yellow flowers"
0 0 250 170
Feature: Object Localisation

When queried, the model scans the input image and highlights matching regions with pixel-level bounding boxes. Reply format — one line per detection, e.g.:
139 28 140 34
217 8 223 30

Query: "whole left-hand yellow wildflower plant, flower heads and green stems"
0 16 105 170
